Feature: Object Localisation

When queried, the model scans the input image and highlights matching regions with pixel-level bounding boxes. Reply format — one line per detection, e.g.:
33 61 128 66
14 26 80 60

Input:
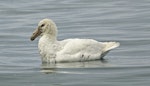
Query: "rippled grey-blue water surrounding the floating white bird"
0 0 150 86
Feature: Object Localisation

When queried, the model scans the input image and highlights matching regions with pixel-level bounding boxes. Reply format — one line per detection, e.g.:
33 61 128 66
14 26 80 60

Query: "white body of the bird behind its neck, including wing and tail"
56 39 119 62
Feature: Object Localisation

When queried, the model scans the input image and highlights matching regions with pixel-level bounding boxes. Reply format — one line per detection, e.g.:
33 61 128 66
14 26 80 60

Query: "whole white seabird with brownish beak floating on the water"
31 19 120 63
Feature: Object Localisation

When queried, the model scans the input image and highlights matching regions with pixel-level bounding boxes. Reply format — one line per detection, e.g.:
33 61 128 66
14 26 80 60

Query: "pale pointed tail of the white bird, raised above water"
104 42 120 52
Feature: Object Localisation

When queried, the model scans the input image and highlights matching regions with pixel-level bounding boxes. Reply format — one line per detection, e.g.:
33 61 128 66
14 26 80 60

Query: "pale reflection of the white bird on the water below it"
41 60 112 74
